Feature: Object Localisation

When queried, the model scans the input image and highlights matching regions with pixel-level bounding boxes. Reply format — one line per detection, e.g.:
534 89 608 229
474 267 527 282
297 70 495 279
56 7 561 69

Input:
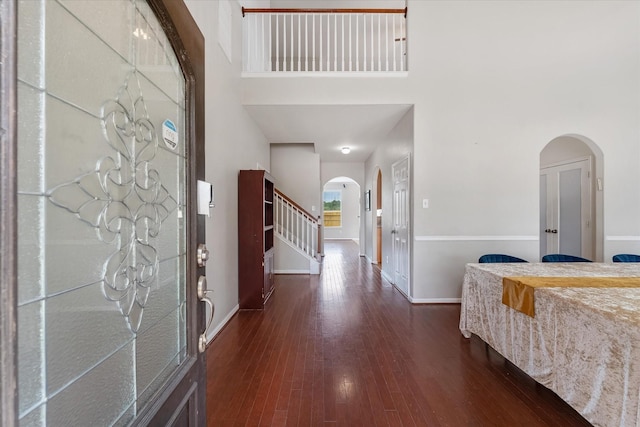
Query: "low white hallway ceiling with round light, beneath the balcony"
245 104 411 162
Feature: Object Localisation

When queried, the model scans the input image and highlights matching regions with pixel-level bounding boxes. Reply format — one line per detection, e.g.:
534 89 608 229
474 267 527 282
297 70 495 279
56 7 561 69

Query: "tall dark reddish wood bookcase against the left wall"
238 170 274 309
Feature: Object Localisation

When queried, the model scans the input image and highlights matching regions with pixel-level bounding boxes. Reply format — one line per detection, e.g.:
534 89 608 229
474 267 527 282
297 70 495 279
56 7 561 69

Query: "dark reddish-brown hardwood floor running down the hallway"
207 242 590 427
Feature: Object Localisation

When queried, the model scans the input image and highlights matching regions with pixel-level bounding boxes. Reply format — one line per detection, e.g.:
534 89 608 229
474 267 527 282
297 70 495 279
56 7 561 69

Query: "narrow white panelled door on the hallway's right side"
391 156 411 296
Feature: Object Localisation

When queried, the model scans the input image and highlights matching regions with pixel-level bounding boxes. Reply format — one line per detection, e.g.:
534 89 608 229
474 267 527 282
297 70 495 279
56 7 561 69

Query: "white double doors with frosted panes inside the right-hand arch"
540 159 593 259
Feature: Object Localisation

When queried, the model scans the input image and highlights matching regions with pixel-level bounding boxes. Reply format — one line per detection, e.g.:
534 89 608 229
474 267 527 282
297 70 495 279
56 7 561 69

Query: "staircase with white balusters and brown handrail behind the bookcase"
273 189 322 274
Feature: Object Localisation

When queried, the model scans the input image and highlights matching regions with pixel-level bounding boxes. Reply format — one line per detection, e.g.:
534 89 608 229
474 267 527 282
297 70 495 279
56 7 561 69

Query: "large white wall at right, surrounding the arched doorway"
409 1 640 300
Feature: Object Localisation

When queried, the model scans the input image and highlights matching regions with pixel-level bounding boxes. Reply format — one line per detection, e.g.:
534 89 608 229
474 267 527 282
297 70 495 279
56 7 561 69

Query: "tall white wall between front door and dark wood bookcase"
186 0 269 339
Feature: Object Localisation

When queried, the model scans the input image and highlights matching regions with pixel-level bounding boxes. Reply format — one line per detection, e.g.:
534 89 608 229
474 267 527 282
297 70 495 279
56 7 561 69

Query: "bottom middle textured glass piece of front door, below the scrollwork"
47 342 135 426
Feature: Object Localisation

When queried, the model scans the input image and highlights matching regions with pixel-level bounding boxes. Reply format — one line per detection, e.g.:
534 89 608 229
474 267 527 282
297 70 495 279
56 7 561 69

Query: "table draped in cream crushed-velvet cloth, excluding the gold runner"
460 263 640 426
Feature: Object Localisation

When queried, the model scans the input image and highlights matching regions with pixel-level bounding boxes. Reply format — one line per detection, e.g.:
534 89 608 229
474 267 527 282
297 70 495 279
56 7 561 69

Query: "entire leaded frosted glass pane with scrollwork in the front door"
18 0 187 426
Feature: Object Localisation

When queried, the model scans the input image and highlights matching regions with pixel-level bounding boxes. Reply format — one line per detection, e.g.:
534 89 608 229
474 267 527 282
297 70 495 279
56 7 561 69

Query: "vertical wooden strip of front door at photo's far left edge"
0 0 18 426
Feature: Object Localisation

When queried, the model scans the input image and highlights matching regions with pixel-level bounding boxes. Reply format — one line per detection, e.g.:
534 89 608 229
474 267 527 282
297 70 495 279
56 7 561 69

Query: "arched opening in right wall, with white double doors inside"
540 135 603 261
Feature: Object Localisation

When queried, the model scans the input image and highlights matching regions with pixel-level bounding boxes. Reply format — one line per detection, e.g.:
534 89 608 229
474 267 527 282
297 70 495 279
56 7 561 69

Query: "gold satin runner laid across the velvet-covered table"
502 276 640 317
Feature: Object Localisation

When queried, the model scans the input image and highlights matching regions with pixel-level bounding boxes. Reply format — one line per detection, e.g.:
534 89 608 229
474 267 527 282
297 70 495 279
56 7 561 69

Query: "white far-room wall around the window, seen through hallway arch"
324 181 364 241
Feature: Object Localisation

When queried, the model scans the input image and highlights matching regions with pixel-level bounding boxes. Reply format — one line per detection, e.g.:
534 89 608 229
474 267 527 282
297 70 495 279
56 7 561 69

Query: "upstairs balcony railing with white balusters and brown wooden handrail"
242 8 407 73
